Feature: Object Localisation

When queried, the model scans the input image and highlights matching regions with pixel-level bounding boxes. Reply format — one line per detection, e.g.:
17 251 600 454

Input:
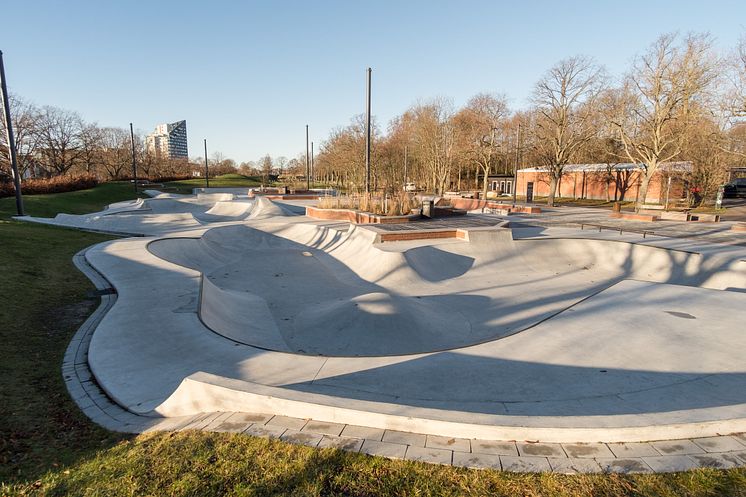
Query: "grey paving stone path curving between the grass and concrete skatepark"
62 251 746 473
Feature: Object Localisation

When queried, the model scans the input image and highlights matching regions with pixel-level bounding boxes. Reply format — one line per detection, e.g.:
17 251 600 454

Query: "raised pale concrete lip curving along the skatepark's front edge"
156 372 746 443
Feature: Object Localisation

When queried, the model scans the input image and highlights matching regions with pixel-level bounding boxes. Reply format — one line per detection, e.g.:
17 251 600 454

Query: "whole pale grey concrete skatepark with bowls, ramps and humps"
21 192 746 472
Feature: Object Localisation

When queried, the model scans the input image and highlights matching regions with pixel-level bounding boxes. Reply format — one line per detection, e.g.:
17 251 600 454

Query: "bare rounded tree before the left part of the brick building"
533 56 606 206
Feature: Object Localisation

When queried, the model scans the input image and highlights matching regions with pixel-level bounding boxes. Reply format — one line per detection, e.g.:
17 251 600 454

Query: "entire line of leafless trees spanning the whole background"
0 33 746 204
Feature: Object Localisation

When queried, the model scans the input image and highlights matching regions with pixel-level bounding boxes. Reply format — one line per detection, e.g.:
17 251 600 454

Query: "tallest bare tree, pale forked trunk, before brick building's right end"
614 34 716 210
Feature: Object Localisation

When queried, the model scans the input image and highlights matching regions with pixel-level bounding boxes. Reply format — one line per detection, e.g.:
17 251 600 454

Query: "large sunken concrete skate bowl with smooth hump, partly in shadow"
148 222 746 357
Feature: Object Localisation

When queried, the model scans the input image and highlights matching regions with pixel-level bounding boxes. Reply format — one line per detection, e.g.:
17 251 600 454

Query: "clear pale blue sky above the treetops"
0 0 746 162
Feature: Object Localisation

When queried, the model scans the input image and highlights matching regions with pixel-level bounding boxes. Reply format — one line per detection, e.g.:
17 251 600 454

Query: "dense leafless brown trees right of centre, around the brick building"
314 34 746 204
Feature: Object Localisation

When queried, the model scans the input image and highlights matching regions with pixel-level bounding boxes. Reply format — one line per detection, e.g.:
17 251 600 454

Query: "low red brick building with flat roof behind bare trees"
517 162 692 204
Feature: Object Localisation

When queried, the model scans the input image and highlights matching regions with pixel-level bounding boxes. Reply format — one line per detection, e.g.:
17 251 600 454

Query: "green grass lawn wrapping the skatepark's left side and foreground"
0 184 746 497
